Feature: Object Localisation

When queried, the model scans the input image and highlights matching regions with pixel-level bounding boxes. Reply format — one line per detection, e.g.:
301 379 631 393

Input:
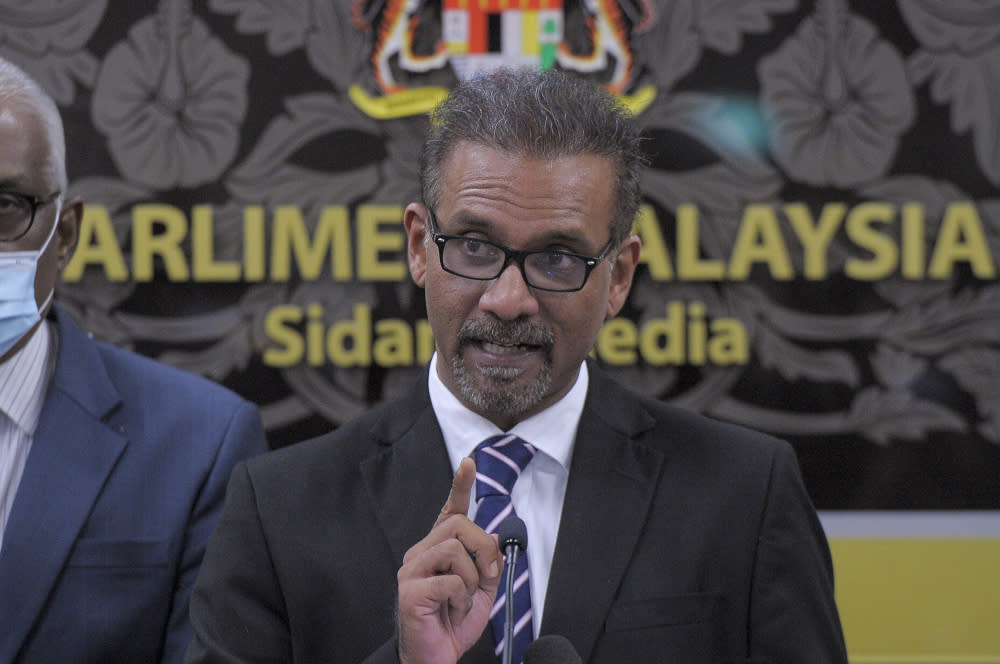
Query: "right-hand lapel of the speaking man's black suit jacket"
541 368 664 662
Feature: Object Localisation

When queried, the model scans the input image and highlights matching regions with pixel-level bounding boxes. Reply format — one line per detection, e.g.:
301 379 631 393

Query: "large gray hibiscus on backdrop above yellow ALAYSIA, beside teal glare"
759 0 915 188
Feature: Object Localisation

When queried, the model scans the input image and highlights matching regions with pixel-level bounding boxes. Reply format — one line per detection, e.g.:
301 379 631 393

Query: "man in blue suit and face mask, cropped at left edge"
0 59 267 664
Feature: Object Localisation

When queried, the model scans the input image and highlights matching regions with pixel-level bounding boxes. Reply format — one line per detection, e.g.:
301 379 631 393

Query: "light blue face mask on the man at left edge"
0 200 62 357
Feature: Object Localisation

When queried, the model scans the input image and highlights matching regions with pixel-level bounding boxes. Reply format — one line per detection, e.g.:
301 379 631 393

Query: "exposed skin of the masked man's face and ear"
0 102 82 361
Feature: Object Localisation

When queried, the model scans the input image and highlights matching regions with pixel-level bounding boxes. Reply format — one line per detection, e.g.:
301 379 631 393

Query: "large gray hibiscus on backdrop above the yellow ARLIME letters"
92 0 249 190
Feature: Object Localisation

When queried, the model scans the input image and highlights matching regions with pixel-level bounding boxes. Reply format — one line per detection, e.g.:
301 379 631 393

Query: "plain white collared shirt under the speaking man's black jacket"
428 353 589 636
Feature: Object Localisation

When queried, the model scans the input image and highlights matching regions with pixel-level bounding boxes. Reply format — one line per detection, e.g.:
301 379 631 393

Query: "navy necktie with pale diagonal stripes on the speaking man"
476 434 537 664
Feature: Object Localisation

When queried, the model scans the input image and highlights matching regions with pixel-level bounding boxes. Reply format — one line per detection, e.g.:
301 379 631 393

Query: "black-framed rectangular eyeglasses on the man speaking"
427 208 612 293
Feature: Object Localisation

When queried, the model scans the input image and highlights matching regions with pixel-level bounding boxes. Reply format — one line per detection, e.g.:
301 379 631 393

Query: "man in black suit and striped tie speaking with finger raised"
188 71 846 664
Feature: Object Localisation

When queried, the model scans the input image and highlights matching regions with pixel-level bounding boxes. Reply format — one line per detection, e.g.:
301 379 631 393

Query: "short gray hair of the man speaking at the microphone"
420 68 645 247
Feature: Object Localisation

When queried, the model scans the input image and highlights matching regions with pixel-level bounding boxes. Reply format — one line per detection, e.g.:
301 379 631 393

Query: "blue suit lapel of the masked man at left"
0 314 127 662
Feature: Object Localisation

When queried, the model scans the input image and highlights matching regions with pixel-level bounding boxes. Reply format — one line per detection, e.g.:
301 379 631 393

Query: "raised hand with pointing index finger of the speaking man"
397 458 503 664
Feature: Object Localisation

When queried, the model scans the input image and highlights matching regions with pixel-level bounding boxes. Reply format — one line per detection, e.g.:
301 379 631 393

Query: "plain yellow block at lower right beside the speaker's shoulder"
830 537 1000 664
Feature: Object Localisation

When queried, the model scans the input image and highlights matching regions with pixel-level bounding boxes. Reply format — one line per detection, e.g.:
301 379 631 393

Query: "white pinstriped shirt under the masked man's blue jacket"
0 321 56 548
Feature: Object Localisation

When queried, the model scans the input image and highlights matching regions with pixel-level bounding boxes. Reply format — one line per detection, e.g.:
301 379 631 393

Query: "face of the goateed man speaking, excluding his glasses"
405 143 639 429
